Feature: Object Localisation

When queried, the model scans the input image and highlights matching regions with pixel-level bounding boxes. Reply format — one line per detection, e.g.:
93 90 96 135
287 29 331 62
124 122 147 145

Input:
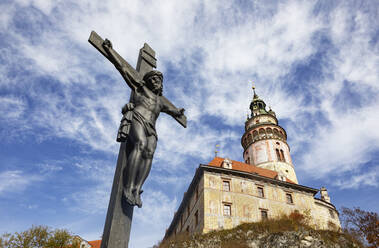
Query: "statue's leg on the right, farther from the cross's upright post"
133 135 157 207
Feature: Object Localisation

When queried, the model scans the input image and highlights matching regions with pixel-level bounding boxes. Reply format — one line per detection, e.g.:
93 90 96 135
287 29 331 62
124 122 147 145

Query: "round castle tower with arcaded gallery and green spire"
241 87 298 183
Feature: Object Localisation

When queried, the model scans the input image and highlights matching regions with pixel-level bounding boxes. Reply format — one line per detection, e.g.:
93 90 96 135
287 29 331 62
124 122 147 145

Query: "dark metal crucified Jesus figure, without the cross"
102 39 184 207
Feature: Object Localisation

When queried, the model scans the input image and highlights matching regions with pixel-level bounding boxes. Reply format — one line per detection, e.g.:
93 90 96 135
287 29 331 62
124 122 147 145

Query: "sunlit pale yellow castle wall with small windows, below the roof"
203 172 340 232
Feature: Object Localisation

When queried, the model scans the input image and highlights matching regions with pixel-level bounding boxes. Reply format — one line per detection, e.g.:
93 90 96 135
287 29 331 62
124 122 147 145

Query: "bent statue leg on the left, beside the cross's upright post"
123 120 147 205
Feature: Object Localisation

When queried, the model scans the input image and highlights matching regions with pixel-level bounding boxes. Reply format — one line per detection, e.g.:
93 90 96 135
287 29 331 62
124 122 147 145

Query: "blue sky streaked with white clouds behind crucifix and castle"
0 0 379 247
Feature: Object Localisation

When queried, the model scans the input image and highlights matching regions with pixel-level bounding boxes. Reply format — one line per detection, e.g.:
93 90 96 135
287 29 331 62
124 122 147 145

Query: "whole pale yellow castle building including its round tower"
164 90 341 239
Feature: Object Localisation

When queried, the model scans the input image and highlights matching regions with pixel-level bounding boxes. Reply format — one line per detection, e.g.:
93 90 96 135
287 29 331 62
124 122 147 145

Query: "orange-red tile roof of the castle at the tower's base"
208 157 294 183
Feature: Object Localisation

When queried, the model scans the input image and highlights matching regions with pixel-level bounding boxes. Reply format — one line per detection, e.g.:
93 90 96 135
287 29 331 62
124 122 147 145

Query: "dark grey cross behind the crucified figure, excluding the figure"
88 31 186 248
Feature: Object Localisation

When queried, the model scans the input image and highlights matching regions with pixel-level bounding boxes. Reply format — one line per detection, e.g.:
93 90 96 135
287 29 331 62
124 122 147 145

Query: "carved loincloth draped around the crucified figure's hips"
117 110 158 142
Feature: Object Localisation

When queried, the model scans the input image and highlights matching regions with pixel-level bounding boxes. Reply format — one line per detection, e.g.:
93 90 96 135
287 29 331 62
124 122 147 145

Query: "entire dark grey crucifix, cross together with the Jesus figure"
88 31 187 248
